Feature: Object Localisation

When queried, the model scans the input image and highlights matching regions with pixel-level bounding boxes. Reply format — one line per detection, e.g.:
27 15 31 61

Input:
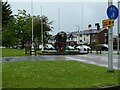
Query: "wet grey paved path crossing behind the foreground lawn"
1 54 120 69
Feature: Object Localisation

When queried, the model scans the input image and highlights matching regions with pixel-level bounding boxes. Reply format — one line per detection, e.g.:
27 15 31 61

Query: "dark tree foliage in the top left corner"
2 1 13 26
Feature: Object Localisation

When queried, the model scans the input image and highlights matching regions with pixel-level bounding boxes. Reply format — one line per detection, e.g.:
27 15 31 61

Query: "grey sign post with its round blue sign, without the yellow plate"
107 0 118 71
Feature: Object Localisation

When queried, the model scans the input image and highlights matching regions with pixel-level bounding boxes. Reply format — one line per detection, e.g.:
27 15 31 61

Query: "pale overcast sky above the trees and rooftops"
4 0 117 35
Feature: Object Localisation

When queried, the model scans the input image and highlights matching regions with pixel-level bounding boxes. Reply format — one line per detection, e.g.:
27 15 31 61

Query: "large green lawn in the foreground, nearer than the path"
2 60 118 88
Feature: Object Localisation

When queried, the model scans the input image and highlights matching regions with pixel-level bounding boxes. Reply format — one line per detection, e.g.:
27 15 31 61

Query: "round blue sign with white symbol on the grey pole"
107 5 119 20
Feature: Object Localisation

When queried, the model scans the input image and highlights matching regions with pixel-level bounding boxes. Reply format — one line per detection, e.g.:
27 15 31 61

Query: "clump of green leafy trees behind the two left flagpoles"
2 10 52 49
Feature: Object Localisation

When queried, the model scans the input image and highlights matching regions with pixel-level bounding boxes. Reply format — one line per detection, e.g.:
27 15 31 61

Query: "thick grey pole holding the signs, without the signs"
108 0 113 71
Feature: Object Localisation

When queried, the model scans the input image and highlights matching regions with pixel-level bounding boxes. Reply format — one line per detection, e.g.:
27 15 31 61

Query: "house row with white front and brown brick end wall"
67 28 108 44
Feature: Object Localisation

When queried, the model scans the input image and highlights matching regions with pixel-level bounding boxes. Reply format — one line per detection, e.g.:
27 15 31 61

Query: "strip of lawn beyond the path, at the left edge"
2 48 29 57
